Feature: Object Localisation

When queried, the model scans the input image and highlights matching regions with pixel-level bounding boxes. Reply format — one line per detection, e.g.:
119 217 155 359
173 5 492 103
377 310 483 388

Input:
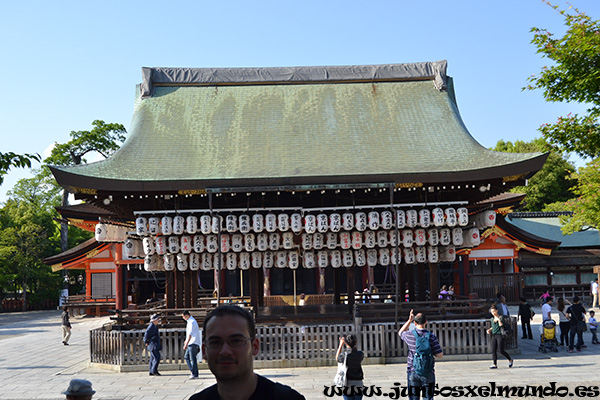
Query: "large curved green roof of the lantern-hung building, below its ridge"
53 63 545 194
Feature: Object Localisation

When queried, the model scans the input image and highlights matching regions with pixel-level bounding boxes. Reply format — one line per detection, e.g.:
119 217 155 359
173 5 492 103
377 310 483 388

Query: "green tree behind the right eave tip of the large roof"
493 139 576 211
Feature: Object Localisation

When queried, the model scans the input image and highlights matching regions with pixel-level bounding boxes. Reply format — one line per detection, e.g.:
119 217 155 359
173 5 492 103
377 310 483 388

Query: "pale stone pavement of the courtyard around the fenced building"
0 307 600 400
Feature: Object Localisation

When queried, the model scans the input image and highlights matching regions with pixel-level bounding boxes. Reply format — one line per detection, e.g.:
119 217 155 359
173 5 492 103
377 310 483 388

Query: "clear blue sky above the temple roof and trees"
0 0 600 201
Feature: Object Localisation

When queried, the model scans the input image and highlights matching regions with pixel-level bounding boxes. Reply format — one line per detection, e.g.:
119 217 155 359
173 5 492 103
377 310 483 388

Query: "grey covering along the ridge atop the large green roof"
141 60 447 98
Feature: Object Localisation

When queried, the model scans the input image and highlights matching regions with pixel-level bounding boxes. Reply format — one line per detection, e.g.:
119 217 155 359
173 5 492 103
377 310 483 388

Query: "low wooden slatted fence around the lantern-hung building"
90 318 517 365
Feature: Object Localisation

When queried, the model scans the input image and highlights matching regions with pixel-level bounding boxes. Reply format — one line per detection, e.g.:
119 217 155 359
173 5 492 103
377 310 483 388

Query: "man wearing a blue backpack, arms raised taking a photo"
398 310 444 400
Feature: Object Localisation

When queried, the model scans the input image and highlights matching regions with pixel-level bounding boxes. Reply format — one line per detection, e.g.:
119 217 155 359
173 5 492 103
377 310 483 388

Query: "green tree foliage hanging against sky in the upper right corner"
524 1 600 158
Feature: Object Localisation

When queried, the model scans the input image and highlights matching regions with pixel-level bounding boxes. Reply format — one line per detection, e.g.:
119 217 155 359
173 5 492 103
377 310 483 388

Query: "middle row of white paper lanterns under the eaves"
124 228 480 258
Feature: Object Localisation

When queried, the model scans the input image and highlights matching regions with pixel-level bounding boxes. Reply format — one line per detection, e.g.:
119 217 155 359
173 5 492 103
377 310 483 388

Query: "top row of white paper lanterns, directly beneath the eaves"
135 207 488 237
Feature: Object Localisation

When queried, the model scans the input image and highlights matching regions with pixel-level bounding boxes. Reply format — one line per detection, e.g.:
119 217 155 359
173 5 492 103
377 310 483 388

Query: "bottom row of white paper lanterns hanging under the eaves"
144 246 456 271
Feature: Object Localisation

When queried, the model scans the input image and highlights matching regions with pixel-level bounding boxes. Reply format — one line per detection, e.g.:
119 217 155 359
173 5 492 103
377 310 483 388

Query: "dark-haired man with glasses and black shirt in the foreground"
190 305 306 400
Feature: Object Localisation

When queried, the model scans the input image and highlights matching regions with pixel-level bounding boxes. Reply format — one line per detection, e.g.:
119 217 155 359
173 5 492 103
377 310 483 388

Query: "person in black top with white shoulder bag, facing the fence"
335 334 365 400
